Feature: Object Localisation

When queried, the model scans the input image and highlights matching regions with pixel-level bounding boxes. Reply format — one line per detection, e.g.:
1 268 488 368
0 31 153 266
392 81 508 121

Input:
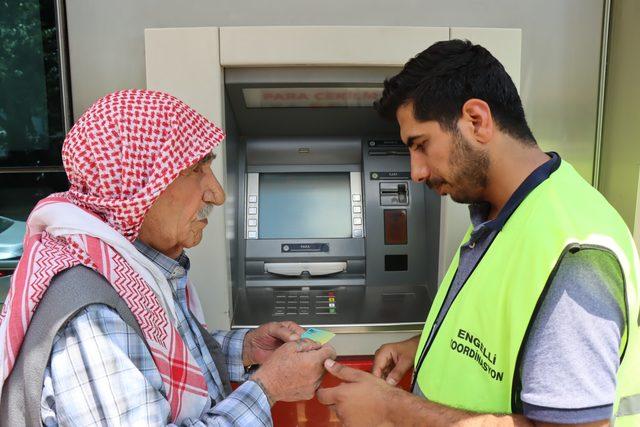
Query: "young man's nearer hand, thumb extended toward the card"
317 360 407 427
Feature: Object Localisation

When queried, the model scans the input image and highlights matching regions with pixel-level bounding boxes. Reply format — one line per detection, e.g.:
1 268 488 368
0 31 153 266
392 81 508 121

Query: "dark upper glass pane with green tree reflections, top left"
0 0 64 167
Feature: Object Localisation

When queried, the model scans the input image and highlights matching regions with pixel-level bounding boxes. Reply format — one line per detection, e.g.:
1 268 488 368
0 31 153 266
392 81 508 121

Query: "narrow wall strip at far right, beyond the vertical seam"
600 0 640 231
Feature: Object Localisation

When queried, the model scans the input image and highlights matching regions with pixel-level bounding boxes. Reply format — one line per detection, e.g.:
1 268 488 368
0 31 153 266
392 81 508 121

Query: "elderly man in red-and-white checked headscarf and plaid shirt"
0 90 335 426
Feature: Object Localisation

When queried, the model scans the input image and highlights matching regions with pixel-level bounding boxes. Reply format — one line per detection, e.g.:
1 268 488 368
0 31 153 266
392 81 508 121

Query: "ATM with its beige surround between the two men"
145 27 521 348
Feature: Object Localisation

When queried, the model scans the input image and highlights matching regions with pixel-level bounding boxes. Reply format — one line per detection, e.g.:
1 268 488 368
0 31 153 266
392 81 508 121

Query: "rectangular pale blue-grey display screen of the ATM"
258 172 351 239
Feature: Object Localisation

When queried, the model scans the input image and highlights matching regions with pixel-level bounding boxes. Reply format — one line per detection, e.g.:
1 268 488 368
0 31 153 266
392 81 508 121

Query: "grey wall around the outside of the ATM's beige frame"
66 0 604 179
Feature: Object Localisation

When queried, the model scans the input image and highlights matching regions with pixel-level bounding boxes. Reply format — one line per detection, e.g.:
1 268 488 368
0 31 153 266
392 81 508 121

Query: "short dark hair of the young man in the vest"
375 40 536 144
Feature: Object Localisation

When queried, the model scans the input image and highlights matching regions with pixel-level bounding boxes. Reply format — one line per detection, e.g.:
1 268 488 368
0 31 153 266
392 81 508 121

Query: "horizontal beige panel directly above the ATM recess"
220 26 449 67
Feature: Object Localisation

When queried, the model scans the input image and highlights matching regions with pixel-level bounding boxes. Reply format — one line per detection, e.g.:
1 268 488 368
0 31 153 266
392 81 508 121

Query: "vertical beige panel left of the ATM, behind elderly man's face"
145 27 230 329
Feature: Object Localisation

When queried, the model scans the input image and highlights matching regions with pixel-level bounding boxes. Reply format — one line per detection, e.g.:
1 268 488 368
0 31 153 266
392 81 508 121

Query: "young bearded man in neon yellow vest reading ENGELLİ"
318 40 640 426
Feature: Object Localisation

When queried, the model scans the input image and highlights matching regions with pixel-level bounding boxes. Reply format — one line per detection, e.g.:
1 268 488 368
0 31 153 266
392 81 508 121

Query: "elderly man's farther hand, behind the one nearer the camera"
242 321 304 366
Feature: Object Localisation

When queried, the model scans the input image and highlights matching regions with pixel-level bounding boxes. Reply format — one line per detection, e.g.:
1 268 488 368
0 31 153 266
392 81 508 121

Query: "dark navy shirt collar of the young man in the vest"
469 152 561 231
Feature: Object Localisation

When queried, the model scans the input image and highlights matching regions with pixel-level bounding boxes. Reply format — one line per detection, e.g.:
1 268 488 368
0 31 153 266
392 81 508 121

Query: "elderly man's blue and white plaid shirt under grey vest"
41 241 273 426
